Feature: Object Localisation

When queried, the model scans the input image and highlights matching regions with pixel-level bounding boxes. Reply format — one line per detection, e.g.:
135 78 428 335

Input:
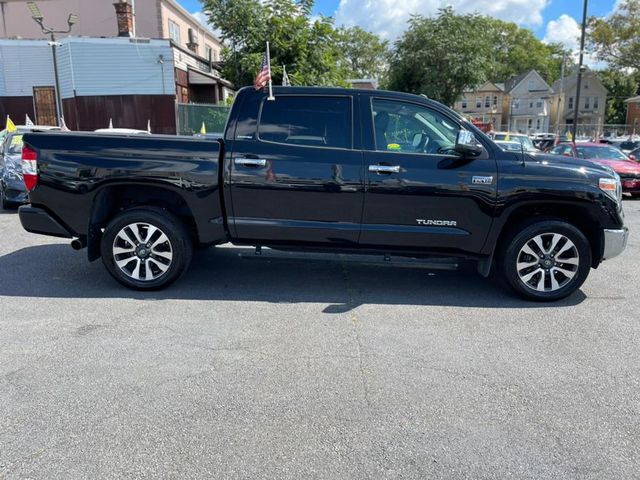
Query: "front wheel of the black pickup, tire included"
500 220 591 302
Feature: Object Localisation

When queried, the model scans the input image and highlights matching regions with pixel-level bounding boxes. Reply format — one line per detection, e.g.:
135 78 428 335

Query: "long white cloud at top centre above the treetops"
335 0 549 40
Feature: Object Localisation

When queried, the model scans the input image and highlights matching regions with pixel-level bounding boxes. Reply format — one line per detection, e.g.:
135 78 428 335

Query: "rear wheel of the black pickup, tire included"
100 207 193 290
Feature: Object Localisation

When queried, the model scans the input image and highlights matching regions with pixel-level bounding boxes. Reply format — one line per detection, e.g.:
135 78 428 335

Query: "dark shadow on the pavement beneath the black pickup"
0 244 586 314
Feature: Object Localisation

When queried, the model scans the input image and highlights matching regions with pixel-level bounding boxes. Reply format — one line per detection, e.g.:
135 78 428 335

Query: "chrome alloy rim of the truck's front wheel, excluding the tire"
516 233 580 292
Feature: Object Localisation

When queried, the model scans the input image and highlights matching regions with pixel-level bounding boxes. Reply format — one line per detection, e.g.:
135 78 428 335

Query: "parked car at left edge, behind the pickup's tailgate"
0 125 59 209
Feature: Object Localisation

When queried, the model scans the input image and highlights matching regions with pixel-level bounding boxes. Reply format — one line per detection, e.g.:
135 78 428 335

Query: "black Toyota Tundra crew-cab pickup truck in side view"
20 87 628 300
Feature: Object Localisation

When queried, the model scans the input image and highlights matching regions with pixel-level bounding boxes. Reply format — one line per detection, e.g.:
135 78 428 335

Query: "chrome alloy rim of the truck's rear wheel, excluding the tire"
113 222 173 282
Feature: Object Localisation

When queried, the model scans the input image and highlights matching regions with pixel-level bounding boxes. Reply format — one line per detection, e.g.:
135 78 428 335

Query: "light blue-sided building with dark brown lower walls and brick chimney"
0 2 234 133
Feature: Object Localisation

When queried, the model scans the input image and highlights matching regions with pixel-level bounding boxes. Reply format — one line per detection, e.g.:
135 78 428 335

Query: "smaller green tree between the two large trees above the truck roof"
337 27 389 80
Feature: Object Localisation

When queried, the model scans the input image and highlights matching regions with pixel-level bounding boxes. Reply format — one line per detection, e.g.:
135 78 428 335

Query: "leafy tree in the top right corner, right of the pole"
588 0 640 70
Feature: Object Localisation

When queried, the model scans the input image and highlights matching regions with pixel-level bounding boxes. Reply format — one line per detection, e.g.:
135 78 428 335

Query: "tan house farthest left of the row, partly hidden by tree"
453 82 507 130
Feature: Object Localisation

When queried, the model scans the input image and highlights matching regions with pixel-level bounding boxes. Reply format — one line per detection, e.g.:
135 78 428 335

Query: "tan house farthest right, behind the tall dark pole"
551 70 609 131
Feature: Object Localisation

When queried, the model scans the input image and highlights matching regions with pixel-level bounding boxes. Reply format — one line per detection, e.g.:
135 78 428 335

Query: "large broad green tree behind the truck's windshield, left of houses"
388 7 563 105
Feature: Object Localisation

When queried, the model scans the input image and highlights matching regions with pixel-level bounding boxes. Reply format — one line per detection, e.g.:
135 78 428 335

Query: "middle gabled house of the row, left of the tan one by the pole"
502 70 553 134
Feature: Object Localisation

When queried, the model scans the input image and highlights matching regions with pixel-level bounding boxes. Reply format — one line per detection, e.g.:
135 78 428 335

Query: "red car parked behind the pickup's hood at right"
549 142 640 197
